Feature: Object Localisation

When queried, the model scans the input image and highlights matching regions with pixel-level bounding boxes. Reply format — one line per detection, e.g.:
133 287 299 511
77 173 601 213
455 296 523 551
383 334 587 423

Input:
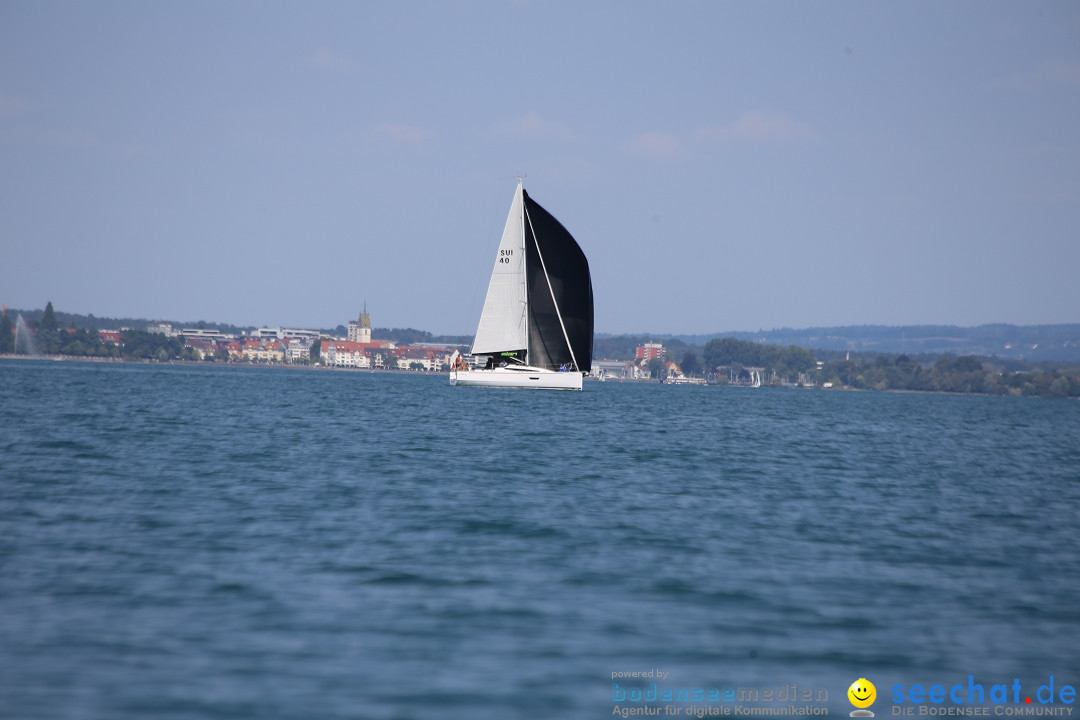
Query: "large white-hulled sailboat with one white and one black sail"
450 178 593 390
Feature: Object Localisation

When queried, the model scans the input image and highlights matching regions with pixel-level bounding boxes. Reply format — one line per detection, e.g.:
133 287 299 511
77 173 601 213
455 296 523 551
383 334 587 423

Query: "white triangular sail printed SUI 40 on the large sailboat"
472 182 528 355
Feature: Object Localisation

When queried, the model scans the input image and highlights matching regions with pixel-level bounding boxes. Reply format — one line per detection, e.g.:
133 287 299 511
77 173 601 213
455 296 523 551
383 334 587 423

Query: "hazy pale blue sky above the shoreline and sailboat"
0 0 1080 335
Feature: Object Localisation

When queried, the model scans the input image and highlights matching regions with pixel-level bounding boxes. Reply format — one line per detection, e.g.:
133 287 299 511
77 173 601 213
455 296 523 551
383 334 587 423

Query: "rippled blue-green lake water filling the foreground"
0 359 1080 720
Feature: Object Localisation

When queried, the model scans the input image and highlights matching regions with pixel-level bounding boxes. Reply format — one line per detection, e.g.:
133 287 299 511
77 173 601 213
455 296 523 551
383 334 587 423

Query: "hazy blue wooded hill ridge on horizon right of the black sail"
597 324 1080 362
